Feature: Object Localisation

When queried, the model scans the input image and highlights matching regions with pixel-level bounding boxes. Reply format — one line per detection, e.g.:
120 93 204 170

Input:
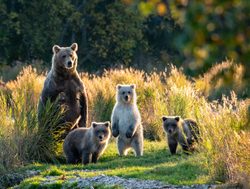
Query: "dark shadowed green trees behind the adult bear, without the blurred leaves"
0 0 180 70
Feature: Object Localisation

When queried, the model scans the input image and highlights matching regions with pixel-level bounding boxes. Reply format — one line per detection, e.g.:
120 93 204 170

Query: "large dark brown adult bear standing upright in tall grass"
38 43 88 134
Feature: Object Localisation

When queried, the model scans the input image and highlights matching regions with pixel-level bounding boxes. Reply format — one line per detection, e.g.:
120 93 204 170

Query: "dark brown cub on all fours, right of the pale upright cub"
162 116 198 154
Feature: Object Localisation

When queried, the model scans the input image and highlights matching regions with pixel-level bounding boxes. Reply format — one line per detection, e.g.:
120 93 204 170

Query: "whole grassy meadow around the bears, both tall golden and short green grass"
0 61 250 188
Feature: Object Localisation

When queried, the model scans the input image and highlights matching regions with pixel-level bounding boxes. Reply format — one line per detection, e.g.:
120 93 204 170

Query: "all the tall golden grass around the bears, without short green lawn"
0 62 250 185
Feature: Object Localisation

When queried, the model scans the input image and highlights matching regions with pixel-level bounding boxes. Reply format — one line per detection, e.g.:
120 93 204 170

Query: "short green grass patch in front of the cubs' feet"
15 141 210 188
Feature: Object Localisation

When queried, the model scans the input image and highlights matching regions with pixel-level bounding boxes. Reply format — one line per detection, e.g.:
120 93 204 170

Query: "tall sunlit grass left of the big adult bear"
0 67 63 174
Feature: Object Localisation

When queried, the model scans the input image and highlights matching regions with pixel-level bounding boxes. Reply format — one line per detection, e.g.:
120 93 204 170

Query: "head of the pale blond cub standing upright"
117 84 135 104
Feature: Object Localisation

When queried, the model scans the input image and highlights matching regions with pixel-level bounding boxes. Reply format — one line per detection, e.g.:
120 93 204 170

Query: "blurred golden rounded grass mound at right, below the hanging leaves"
195 61 245 100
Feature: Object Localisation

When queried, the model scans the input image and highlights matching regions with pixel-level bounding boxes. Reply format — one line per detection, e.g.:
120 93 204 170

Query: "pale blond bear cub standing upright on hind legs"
111 85 143 156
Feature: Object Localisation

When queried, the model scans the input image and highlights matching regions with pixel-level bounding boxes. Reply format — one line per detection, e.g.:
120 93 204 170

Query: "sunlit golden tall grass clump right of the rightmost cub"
198 92 250 184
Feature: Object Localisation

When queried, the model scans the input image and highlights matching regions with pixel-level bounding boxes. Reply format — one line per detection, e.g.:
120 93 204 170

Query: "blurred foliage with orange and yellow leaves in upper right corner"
172 0 250 77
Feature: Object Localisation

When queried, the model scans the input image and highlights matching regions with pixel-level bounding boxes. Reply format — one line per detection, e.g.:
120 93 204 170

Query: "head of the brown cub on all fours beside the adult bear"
92 121 111 143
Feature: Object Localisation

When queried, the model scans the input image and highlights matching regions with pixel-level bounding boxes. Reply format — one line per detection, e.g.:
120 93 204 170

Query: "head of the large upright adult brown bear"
53 43 78 70
